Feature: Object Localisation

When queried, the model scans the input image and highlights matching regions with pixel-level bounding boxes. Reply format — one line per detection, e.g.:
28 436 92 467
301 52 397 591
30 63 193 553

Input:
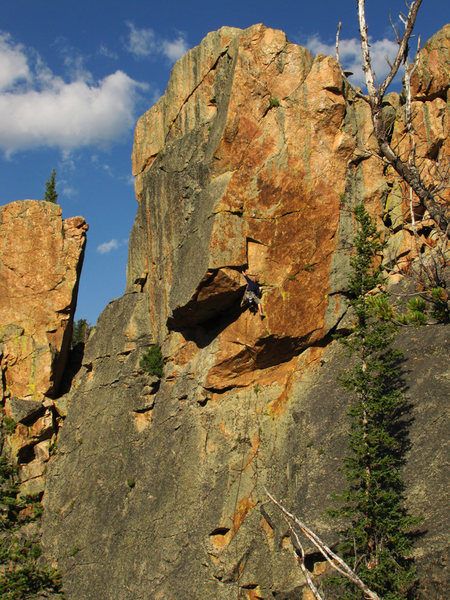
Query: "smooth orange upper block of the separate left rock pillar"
0 200 88 400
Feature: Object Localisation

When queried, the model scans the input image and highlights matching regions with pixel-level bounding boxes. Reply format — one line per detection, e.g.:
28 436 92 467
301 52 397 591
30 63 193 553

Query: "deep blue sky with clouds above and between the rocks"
0 0 450 324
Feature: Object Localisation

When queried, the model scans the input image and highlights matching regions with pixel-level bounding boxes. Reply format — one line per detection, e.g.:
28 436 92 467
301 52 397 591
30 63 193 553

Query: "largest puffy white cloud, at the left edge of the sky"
0 34 146 154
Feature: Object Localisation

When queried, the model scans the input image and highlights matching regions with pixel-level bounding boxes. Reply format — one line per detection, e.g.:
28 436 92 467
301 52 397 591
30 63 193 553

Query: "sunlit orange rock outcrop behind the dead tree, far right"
386 25 450 251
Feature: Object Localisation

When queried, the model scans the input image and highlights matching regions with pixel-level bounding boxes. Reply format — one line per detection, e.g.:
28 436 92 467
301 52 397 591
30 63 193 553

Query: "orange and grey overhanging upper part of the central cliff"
128 25 355 387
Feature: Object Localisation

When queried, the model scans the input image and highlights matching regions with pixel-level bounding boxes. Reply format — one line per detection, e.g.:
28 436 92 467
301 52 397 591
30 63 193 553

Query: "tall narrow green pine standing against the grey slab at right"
330 205 418 600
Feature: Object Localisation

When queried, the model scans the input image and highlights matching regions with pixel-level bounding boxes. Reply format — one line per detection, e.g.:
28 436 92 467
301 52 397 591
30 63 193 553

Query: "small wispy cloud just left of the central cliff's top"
126 21 189 62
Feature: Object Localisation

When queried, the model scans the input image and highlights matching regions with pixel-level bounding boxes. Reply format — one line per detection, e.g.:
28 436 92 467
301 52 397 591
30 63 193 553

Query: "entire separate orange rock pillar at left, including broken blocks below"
0 200 87 492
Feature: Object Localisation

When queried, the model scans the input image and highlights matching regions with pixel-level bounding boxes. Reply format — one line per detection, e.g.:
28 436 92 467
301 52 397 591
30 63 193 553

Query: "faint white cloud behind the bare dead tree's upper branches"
306 34 398 85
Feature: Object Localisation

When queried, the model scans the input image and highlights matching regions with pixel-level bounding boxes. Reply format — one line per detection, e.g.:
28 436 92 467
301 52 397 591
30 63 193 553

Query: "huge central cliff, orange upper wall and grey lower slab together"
40 25 448 600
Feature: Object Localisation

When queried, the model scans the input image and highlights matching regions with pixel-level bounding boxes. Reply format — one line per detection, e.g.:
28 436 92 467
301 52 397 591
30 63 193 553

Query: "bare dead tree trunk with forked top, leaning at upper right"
358 0 450 237
